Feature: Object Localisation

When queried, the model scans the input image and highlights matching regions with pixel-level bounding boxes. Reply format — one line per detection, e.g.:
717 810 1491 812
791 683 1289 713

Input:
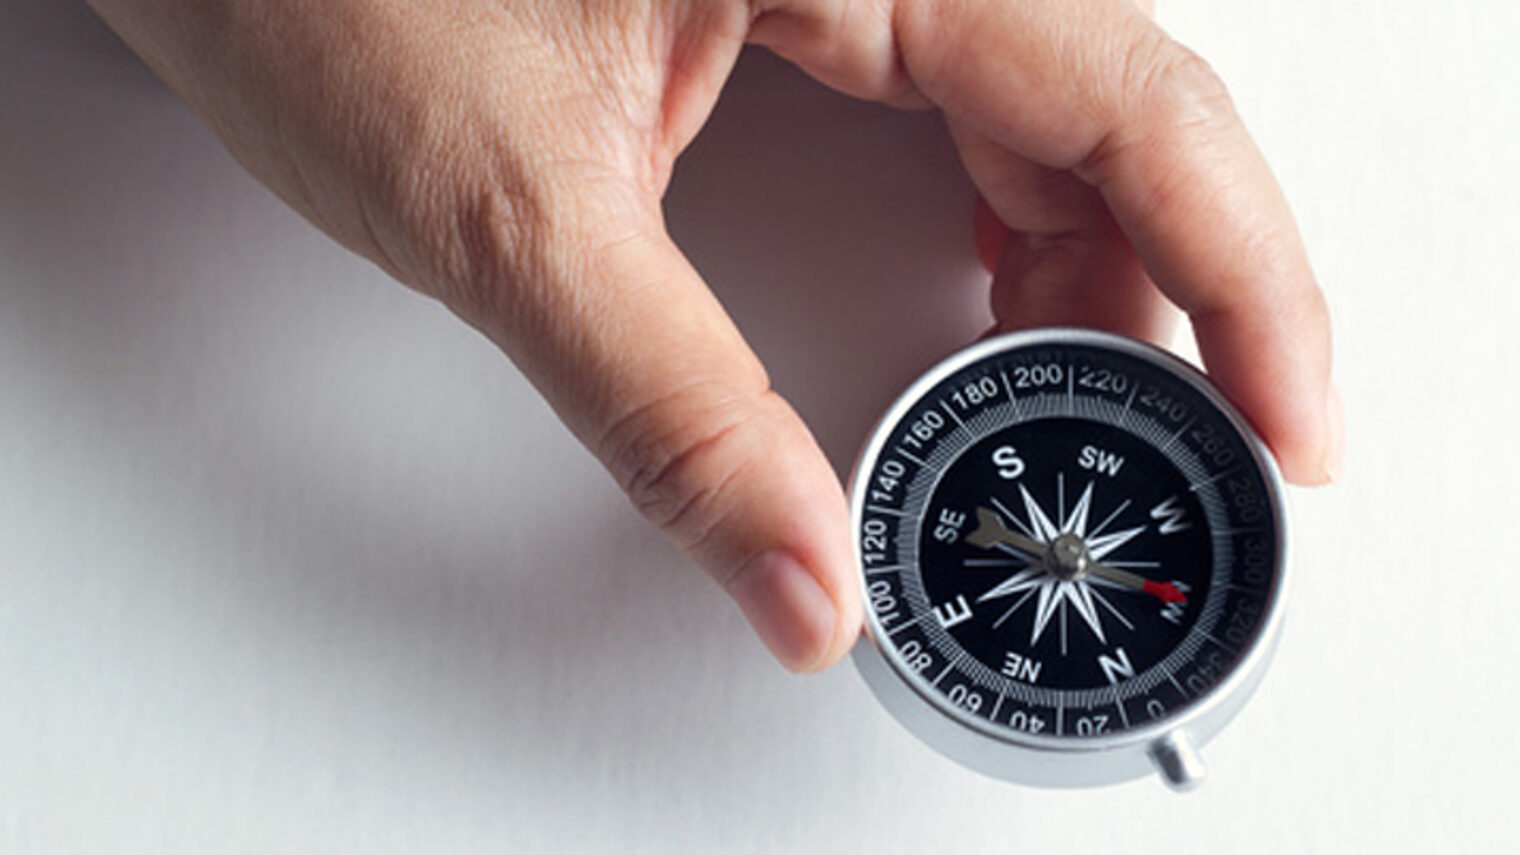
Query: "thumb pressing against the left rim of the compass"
488 206 862 671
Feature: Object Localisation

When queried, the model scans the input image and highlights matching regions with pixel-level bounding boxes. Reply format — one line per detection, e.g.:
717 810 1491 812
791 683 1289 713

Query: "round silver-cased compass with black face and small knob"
850 329 1286 788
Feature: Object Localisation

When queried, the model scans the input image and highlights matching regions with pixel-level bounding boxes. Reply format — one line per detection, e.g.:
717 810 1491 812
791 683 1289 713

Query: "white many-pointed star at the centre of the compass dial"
973 476 1146 654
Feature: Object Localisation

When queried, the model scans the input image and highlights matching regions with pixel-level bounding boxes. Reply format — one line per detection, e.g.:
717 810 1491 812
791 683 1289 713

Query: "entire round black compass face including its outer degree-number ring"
854 336 1277 738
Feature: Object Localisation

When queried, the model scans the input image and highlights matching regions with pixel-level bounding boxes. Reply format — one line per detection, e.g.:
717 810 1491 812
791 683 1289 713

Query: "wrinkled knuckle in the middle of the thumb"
597 386 763 551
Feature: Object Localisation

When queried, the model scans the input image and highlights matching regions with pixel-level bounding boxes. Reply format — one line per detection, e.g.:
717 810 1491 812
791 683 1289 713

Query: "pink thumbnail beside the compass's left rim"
728 551 838 671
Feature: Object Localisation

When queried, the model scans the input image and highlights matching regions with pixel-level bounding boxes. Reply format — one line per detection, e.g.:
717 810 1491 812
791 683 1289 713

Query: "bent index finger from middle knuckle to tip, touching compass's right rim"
1079 55 1339 484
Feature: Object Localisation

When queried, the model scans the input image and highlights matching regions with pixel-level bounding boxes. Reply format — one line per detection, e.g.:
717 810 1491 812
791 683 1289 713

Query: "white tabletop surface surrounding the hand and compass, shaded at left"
0 0 1520 855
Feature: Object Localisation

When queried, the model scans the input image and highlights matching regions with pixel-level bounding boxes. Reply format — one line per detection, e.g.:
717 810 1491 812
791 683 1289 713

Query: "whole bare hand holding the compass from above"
91 0 1341 671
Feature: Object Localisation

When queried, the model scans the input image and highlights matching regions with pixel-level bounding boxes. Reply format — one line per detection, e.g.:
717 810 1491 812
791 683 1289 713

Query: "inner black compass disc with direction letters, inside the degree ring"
918 418 1213 689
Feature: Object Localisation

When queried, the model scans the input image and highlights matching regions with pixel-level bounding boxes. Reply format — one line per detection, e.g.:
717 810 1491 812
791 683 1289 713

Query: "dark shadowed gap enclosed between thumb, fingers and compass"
666 47 991 475
